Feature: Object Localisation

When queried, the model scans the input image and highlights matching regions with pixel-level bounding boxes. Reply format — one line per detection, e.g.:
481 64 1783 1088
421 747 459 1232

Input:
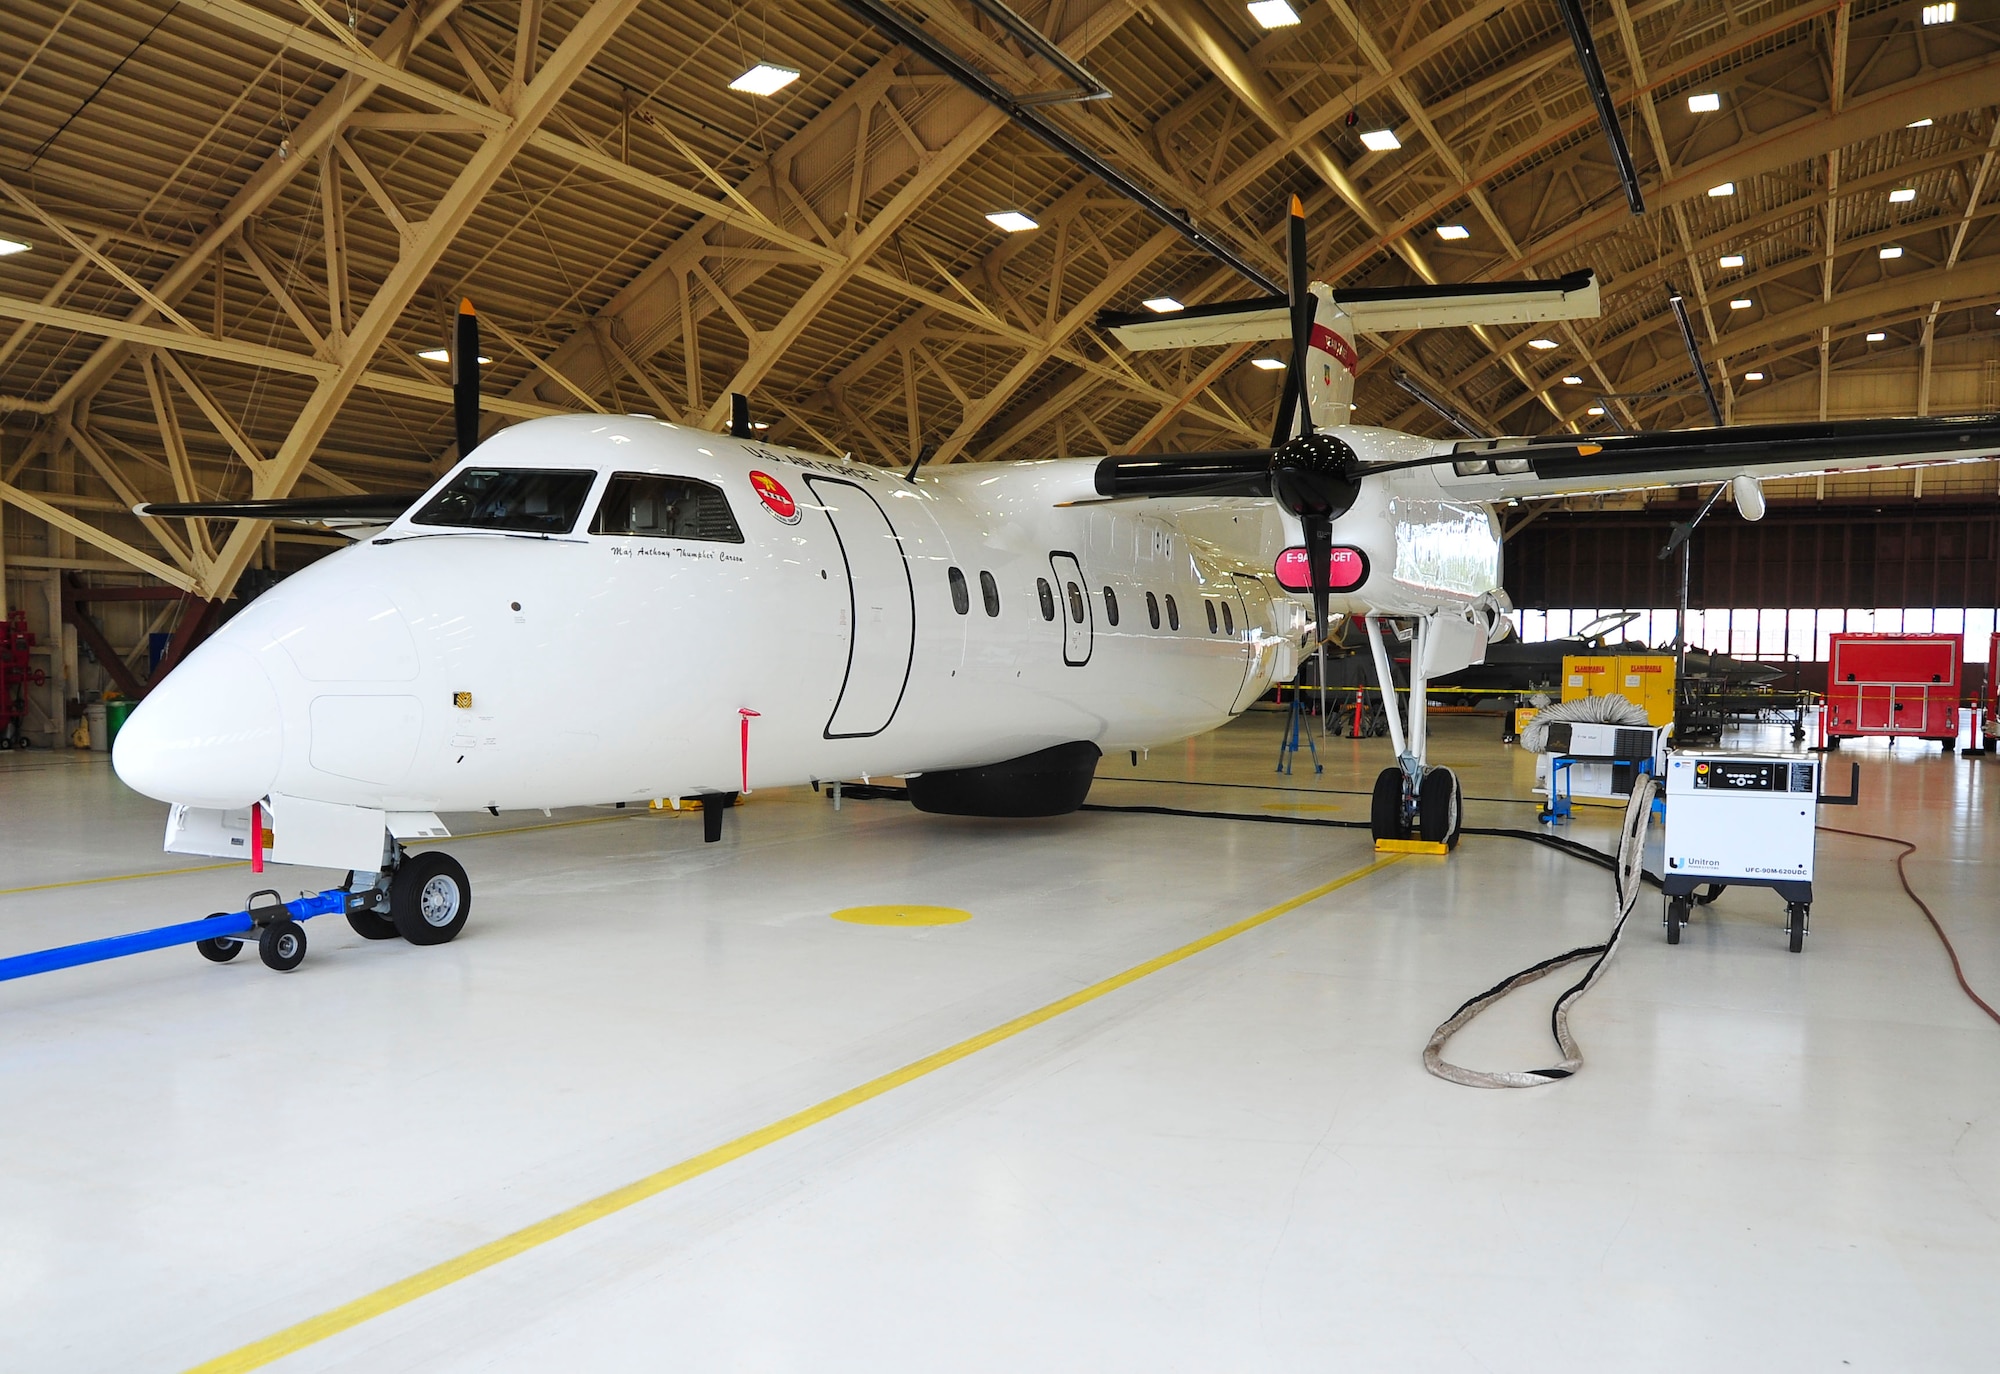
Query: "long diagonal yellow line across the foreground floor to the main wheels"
188 854 1402 1374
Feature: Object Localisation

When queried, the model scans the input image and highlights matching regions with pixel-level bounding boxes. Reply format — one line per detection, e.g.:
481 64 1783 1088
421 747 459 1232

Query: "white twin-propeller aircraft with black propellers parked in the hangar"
114 208 2000 944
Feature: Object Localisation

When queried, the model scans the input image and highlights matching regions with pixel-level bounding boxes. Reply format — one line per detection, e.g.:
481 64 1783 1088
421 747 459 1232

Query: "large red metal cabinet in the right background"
1826 634 1966 748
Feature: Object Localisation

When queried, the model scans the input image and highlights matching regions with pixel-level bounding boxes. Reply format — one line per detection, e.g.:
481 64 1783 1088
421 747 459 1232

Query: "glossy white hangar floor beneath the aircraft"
0 714 2000 1374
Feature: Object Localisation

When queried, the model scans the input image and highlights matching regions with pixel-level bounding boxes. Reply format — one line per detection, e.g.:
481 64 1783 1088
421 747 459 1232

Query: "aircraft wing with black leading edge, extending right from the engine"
1432 414 2000 500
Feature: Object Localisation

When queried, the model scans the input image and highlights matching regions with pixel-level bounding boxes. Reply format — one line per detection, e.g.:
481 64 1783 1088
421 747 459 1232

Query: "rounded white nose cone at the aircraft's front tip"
112 644 284 810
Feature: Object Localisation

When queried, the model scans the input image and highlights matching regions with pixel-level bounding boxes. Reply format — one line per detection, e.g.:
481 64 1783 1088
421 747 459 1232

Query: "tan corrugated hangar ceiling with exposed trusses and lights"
0 0 2000 596
